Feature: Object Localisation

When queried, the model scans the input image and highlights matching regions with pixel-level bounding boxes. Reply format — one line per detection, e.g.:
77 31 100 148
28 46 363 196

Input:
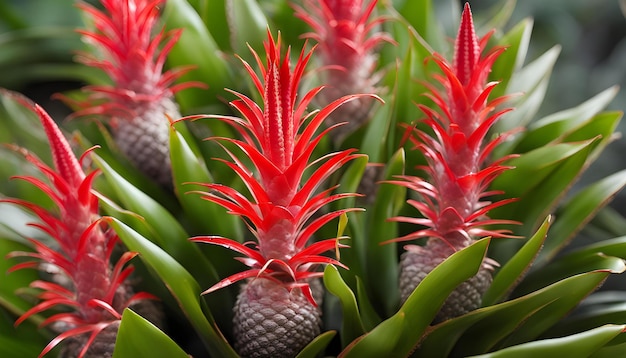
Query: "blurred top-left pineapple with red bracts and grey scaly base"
74 0 203 186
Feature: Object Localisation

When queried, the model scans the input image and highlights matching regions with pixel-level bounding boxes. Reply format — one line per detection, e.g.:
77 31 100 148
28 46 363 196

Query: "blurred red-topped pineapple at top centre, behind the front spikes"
293 0 394 141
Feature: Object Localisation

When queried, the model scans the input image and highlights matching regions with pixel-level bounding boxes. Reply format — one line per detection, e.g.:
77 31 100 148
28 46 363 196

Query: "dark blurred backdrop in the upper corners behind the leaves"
0 0 626 208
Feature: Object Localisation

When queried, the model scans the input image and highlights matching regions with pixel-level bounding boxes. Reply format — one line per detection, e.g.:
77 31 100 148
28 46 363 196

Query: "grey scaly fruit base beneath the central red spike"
233 278 321 358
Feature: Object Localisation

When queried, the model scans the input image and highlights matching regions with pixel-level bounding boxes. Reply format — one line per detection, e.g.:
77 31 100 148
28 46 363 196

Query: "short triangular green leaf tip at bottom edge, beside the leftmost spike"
113 308 189 358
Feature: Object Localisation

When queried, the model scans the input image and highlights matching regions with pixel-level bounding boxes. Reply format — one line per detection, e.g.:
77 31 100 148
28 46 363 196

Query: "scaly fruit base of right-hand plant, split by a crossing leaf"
399 240 493 323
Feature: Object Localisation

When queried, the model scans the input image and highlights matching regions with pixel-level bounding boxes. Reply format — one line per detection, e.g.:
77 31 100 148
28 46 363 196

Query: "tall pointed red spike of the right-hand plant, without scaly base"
392 3 510 249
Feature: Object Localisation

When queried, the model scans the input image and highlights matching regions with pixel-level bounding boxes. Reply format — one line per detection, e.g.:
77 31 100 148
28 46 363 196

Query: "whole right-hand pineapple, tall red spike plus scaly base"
391 4 514 321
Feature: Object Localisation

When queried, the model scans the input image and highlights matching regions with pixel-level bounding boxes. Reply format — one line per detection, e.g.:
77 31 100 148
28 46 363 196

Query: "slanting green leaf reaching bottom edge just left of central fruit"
107 217 238 358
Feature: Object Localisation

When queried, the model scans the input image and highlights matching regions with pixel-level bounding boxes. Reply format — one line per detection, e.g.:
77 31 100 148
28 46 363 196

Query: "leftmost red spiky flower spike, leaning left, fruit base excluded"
3 105 152 357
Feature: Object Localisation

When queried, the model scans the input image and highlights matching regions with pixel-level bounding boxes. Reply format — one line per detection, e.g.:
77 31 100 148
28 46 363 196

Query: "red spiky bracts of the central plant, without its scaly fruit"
192 32 378 301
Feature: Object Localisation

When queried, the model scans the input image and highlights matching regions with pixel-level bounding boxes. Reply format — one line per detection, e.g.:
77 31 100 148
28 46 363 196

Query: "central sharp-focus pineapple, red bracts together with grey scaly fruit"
192 31 378 357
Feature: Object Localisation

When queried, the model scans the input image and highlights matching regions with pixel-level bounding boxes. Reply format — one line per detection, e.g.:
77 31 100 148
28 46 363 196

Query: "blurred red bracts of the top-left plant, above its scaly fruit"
71 0 197 117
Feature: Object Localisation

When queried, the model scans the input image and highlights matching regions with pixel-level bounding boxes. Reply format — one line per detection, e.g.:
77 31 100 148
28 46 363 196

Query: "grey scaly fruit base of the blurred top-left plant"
113 97 180 186
